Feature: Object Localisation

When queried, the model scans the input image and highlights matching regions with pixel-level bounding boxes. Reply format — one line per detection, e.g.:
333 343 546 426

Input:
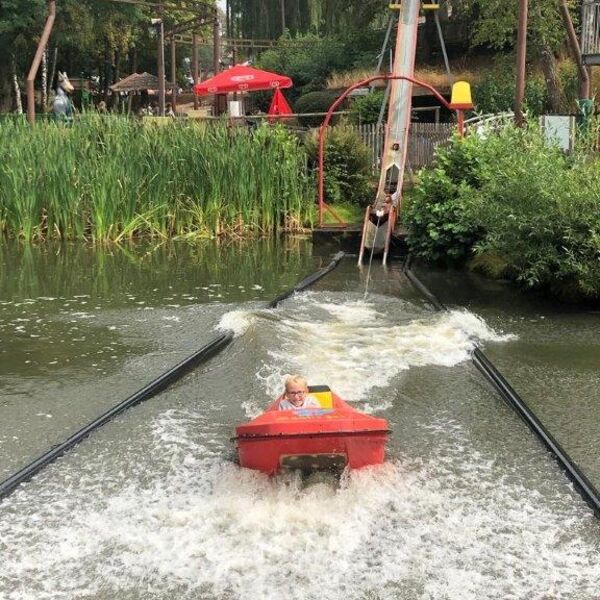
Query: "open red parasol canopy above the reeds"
194 65 293 96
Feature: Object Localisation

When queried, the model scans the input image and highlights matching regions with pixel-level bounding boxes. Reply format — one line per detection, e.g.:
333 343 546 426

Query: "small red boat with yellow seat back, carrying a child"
233 385 389 475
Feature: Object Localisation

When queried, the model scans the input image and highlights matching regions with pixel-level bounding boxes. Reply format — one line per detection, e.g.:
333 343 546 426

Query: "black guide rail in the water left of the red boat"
0 252 344 501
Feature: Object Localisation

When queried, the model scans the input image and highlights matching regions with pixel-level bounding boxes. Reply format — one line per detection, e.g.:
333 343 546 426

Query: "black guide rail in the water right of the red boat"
404 257 600 518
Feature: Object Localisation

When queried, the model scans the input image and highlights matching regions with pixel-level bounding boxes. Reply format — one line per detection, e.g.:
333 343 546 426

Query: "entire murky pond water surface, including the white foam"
0 238 600 600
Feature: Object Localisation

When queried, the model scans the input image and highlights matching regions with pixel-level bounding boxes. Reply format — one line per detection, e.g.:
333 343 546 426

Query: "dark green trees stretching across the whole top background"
0 0 579 110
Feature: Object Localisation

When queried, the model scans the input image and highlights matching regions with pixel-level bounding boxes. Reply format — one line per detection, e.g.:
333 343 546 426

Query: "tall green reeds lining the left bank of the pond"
0 115 314 241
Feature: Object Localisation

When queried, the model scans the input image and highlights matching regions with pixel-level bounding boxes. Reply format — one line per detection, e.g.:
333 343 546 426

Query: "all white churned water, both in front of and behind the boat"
0 295 600 600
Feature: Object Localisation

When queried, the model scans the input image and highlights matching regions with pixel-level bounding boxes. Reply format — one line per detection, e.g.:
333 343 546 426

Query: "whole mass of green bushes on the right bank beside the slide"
405 120 600 302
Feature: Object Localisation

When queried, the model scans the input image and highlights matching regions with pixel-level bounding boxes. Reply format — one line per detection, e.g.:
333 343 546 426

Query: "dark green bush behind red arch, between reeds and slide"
305 125 371 205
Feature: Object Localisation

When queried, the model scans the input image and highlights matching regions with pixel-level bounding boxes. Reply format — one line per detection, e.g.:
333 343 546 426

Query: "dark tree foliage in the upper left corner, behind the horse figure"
0 0 216 110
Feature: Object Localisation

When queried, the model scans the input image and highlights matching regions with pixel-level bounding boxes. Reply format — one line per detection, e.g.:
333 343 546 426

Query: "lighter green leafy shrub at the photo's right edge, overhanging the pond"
475 128 600 299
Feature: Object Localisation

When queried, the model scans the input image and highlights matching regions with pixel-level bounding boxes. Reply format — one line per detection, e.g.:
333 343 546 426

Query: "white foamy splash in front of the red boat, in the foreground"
0 411 600 600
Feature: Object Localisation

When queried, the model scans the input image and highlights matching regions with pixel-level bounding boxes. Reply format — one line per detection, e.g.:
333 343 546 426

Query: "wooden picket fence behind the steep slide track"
352 123 456 173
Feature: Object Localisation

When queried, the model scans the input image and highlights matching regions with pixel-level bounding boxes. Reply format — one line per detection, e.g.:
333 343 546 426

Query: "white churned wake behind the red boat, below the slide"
244 294 515 401
